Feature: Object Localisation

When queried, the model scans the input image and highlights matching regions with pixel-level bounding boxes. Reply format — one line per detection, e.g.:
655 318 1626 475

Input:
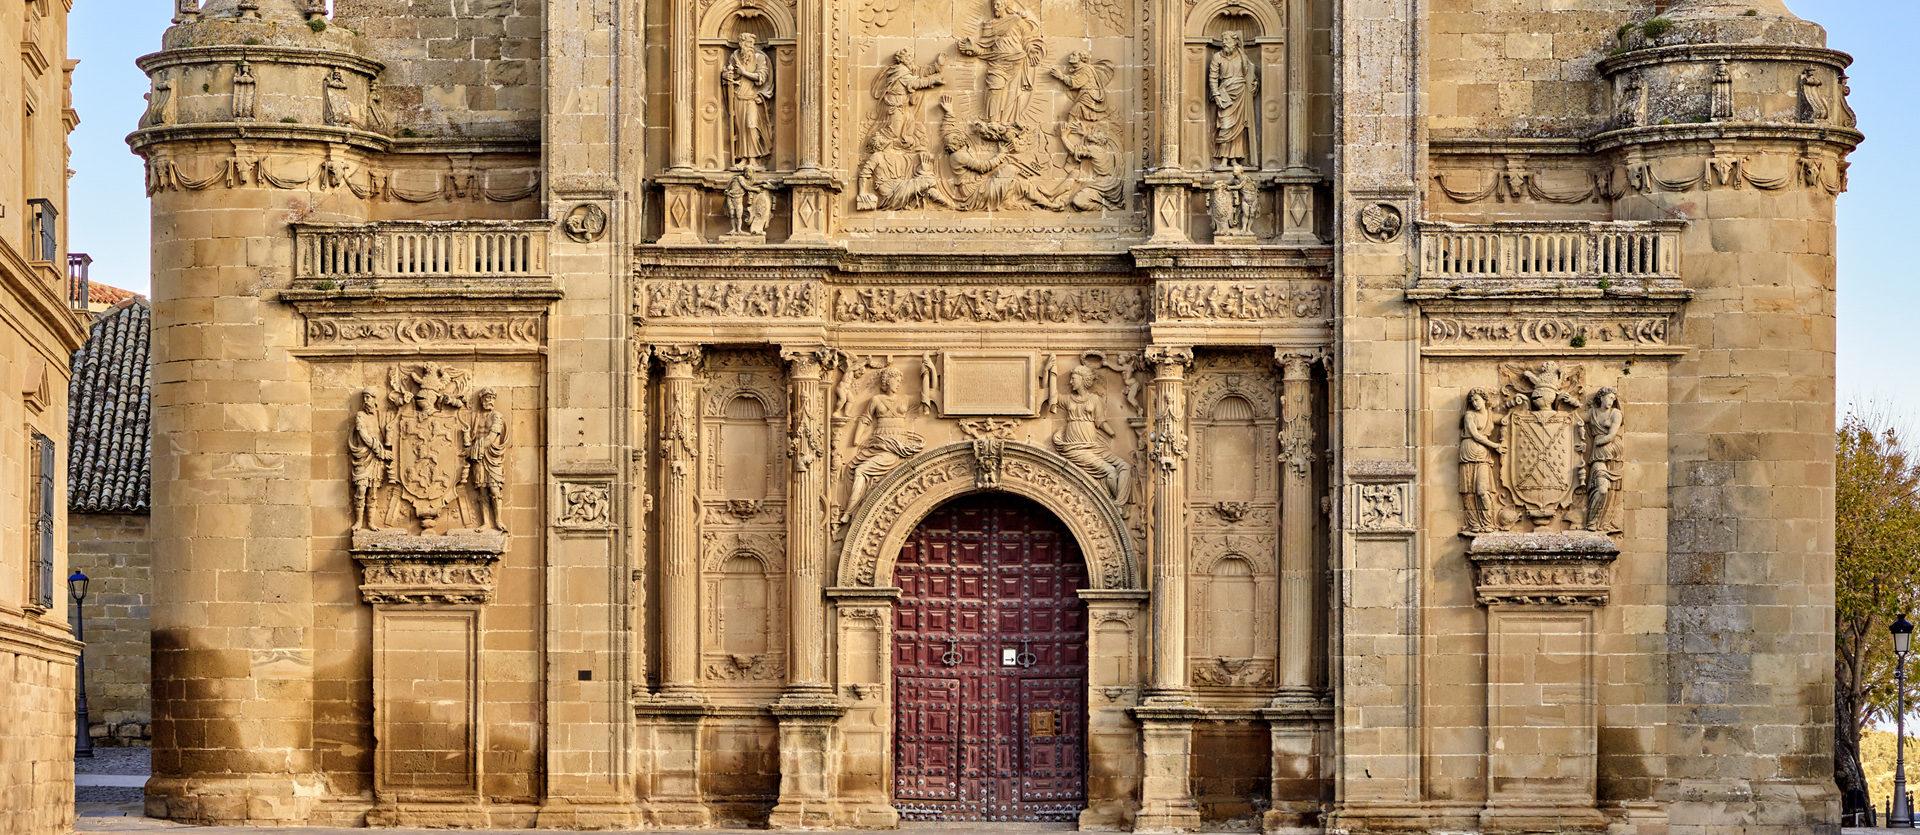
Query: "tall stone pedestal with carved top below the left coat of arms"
353 530 507 827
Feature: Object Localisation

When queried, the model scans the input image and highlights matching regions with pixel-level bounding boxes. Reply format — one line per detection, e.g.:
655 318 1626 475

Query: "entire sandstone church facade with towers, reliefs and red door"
129 0 1860 835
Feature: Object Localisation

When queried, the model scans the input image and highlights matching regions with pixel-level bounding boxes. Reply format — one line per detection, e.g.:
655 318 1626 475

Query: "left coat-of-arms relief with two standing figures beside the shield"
348 363 511 536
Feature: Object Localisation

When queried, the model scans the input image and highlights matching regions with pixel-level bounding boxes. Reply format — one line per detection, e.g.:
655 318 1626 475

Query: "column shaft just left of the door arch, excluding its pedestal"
781 346 833 701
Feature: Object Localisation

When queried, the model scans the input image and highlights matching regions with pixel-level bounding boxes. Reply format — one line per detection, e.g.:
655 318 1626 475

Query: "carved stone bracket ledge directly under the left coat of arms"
353 530 507 605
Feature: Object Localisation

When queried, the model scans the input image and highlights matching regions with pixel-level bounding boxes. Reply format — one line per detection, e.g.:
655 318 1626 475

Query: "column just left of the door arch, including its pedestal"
768 346 845 829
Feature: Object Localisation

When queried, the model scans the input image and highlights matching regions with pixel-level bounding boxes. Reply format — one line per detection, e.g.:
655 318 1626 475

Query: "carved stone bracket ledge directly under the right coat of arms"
1467 530 1620 607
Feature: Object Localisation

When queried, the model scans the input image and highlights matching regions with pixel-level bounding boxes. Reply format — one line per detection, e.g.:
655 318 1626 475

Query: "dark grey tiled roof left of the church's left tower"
67 296 154 513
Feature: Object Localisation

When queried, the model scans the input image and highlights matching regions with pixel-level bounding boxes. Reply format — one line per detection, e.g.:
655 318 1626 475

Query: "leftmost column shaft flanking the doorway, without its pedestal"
653 346 701 701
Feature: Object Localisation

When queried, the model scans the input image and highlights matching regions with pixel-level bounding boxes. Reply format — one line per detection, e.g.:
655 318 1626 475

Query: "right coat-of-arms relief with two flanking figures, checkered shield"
1457 361 1626 536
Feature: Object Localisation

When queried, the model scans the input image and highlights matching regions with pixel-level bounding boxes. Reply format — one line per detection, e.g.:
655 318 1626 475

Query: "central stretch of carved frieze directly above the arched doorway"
833 286 1146 324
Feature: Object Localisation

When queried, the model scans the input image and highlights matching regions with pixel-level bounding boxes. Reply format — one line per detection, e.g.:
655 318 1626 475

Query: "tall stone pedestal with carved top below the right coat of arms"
1467 532 1620 833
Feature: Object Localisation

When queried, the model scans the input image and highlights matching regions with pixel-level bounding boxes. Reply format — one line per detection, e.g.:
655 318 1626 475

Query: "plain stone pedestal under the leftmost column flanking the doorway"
634 699 712 827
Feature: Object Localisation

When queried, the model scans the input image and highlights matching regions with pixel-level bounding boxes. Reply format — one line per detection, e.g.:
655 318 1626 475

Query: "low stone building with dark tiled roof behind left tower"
67 297 154 745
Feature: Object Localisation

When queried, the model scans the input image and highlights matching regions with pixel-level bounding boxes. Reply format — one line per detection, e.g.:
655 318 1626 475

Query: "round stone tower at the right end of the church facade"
1596 0 1860 833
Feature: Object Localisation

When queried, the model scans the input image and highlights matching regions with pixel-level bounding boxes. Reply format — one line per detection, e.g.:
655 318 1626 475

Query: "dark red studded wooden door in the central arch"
893 493 1087 822
